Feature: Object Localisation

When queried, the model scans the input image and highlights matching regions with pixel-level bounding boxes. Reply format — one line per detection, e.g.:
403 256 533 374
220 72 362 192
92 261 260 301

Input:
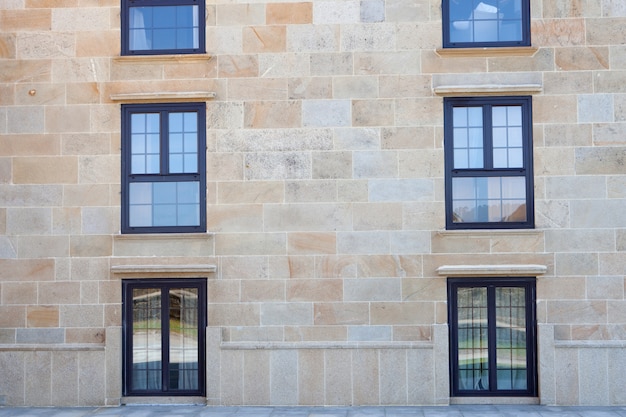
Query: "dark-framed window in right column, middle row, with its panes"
444 97 534 229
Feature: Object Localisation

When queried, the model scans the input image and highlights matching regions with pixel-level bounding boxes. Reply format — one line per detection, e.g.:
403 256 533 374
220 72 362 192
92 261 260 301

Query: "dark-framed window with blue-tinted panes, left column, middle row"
122 103 206 233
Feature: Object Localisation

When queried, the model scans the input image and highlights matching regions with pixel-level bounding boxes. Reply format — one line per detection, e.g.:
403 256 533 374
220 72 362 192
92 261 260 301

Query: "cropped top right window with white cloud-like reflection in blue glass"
442 0 530 48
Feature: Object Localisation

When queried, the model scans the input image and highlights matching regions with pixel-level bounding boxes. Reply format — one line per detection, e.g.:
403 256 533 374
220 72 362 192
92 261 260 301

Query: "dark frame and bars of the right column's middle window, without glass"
444 96 535 230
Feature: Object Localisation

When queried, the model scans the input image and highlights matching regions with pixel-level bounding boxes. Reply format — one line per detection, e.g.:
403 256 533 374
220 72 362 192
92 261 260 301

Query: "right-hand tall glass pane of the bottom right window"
495 287 528 390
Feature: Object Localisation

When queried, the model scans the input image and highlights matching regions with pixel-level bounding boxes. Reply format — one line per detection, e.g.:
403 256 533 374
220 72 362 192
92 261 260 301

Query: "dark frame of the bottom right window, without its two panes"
448 277 538 397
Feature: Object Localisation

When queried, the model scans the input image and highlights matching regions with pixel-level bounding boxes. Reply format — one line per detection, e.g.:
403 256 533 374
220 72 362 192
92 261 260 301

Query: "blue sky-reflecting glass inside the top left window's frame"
129 5 199 51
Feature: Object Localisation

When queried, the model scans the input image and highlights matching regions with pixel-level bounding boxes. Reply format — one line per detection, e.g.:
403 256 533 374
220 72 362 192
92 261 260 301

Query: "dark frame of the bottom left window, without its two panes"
122 278 207 397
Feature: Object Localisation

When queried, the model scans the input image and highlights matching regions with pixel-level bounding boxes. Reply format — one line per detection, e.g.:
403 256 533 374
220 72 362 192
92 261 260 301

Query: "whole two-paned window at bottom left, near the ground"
122 279 206 396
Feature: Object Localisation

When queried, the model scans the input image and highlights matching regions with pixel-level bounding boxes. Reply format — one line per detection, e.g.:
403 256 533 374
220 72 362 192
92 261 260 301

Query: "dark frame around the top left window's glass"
120 0 206 55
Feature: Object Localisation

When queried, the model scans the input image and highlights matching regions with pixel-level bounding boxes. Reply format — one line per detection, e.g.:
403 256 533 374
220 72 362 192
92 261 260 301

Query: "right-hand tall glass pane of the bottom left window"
168 288 199 390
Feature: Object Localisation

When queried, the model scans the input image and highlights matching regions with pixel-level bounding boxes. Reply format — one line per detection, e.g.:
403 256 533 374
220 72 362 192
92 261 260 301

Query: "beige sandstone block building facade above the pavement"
0 0 626 406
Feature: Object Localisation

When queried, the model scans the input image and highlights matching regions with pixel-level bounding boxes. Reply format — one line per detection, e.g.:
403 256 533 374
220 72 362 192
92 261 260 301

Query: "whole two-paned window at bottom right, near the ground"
448 278 537 396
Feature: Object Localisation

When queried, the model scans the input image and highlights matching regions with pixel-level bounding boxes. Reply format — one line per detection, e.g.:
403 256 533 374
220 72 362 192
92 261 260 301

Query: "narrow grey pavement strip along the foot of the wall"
0 405 626 417
